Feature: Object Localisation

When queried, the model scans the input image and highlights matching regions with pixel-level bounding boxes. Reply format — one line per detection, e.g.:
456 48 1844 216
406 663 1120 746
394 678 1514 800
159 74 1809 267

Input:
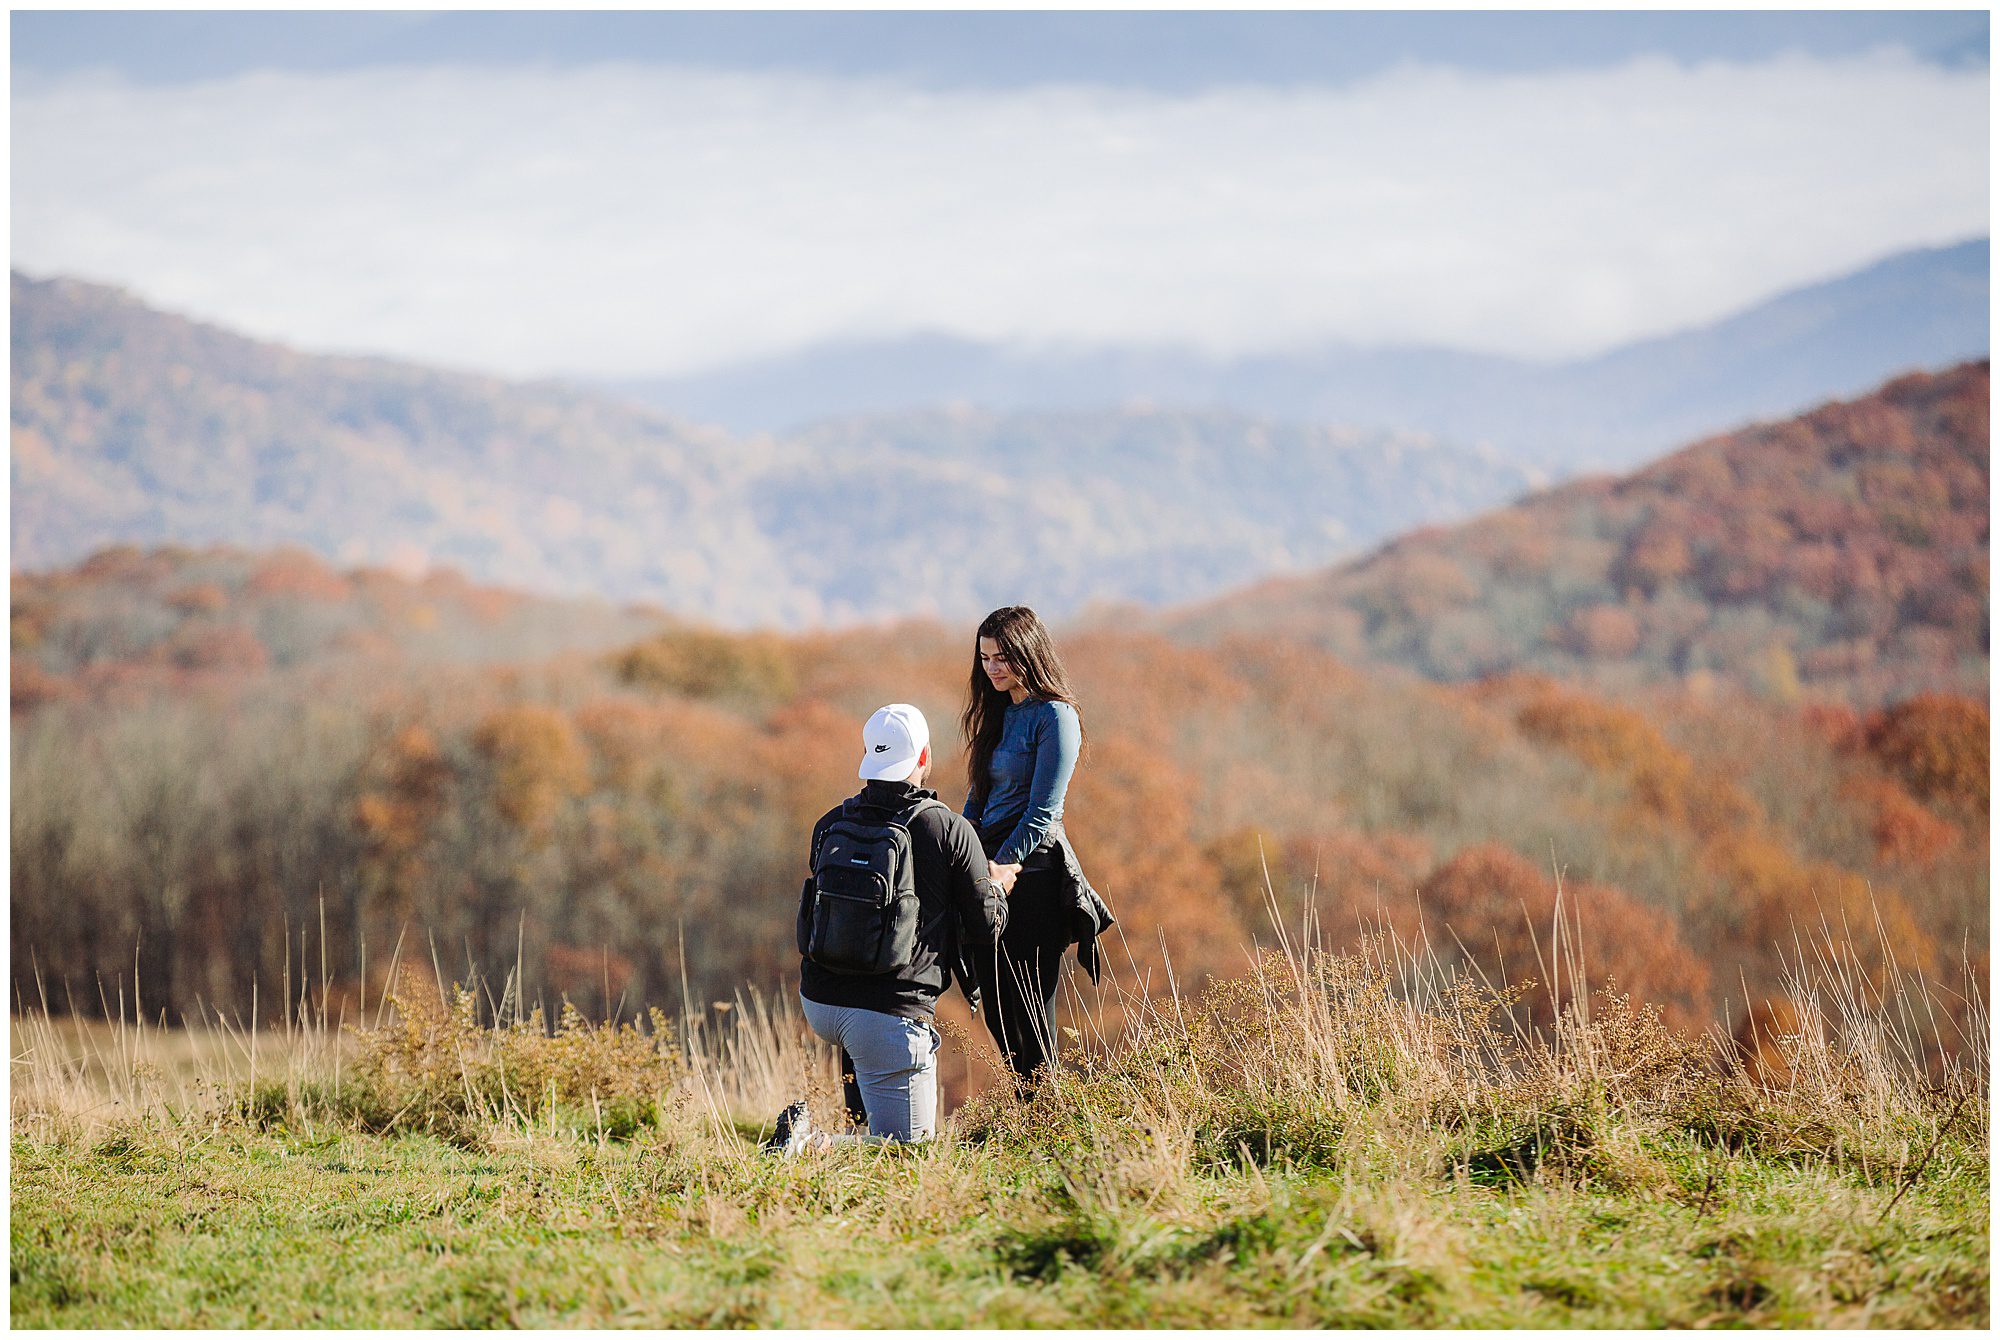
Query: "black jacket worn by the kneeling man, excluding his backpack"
798 782 1006 1020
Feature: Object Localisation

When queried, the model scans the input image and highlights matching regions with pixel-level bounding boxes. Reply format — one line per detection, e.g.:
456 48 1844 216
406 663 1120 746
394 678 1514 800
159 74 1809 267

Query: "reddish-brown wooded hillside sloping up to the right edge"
1168 360 1990 702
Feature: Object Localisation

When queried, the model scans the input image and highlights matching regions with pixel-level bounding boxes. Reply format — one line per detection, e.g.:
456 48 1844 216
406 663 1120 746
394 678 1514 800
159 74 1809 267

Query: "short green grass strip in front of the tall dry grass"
10 1088 1990 1328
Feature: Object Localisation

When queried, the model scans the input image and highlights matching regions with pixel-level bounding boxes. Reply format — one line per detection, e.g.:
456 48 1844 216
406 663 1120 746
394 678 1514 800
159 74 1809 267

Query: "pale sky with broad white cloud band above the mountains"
12 14 1988 376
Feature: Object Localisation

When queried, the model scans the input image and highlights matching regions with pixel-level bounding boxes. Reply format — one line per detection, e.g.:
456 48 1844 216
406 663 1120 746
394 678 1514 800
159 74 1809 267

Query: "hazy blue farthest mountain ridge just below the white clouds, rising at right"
616 238 1990 472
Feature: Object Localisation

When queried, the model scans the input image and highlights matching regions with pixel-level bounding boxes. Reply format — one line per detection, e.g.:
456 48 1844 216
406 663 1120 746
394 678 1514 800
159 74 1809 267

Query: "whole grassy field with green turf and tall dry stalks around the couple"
10 928 1990 1328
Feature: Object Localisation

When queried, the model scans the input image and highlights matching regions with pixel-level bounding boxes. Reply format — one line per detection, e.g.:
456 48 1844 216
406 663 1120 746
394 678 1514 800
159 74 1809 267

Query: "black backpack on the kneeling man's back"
798 796 948 976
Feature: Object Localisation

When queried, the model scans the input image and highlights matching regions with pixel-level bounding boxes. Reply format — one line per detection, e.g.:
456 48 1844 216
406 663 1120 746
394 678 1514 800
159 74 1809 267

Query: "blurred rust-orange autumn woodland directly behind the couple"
12 550 1988 1104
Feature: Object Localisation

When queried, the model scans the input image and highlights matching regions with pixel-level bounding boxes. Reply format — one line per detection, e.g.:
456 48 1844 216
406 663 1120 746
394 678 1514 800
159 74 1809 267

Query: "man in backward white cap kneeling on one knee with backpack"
764 702 1012 1154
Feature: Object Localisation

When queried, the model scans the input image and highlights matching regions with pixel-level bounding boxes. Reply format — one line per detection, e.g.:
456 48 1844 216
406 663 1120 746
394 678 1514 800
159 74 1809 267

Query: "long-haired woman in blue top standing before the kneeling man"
962 604 1110 1080
